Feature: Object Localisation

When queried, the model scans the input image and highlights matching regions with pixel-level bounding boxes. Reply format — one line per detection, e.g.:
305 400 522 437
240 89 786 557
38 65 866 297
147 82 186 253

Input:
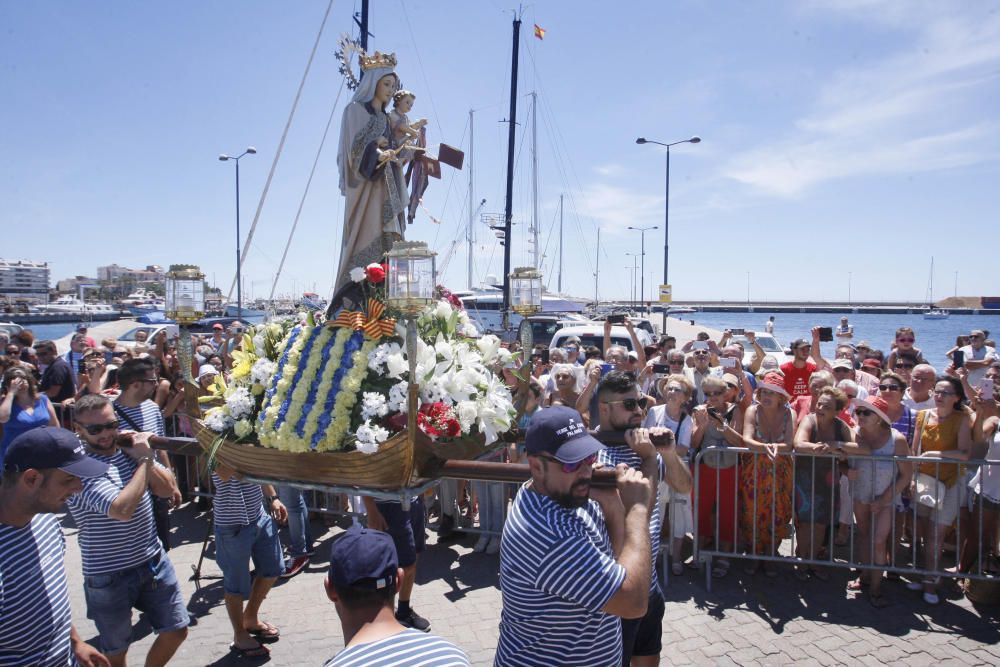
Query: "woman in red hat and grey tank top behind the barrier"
847 396 913 608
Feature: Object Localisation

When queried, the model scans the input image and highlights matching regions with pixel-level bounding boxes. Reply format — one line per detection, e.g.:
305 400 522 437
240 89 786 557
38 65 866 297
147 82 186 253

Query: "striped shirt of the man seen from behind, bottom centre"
323 628 469 667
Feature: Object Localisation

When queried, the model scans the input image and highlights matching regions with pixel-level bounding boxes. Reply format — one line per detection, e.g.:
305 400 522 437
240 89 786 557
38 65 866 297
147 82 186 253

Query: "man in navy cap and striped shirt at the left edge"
0 426 110 667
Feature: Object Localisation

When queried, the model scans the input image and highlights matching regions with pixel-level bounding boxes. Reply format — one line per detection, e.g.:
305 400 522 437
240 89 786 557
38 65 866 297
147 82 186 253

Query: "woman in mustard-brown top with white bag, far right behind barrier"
907 377 972 604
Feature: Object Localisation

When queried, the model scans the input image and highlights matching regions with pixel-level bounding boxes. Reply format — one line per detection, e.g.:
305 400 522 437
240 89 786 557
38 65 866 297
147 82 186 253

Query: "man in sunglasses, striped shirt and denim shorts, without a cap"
68 394 190 667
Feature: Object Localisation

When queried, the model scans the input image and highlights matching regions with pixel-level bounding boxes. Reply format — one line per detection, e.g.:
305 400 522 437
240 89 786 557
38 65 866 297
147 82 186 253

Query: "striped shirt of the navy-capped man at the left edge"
0 514 77 667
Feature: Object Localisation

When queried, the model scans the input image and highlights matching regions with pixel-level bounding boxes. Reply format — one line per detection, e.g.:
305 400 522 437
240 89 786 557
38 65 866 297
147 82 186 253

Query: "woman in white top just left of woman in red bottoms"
642 376 694 576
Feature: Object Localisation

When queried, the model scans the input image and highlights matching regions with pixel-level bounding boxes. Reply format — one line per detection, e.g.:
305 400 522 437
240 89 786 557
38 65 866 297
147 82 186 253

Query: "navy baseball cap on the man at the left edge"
3 426 108 477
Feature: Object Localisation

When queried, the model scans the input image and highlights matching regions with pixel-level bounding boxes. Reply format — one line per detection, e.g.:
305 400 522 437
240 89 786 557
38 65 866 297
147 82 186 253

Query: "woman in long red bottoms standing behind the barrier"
691 376 743 577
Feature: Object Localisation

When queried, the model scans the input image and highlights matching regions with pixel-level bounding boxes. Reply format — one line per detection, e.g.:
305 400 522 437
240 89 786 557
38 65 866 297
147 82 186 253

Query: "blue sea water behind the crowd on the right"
676 310 1000 370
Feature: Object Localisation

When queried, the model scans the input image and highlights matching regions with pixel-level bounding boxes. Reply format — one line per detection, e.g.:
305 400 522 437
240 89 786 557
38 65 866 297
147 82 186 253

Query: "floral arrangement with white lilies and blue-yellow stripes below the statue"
205 264 516 454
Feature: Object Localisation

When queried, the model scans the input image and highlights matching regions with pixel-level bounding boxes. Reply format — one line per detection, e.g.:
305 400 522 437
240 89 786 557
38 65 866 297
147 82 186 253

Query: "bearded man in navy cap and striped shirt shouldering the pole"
496 406 658 666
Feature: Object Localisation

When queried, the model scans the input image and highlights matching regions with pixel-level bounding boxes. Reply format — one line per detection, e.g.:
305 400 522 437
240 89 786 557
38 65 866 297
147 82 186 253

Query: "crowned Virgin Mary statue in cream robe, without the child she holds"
334 51 408 292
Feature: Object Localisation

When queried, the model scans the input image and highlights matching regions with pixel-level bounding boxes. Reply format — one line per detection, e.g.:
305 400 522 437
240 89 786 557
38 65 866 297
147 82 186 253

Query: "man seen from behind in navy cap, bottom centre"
324 525 469 667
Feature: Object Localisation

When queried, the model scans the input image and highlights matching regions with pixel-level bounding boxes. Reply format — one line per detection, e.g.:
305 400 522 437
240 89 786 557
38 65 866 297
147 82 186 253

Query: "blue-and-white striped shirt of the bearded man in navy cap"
495 482 625 667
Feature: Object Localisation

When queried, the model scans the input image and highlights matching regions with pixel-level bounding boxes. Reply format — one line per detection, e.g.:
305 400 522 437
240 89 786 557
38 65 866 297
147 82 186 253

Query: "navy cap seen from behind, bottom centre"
329 525 399 591
